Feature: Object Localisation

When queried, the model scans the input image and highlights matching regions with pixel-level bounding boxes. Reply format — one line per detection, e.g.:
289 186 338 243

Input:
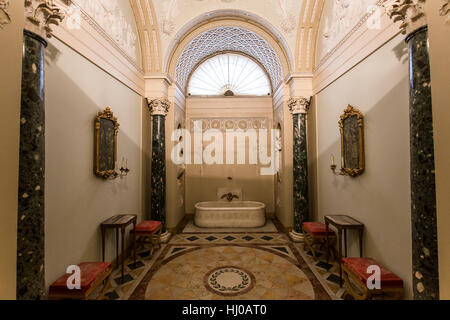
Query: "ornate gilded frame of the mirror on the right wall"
339 105 365 177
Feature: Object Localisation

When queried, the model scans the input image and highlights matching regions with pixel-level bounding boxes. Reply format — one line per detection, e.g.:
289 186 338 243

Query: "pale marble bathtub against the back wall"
194 201 266 228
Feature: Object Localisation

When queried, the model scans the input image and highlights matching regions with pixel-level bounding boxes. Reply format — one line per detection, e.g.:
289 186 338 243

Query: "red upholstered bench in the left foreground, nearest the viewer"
49 262 113 300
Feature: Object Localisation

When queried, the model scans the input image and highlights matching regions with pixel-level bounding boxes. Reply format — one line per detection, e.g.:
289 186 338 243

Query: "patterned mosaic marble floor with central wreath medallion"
92 220 345 300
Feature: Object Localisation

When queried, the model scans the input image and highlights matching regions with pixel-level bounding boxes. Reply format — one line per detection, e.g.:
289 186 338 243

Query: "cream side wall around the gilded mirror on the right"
308 35 412 298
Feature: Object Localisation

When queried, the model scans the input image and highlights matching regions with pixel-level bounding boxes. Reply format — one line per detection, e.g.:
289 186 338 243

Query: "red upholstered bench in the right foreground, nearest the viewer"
342 258 403 300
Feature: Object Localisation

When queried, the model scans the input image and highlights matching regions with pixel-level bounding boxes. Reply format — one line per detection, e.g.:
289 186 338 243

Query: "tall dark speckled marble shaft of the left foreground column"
16 31 46 300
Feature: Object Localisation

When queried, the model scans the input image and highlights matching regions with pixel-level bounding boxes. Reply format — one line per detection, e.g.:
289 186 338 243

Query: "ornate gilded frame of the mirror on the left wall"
94 107 120 179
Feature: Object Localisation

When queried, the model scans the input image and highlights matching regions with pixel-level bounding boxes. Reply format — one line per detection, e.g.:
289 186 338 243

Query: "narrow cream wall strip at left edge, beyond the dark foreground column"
0 1 24 300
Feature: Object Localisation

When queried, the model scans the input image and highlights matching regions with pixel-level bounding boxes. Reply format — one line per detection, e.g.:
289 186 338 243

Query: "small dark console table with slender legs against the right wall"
325 215 364 287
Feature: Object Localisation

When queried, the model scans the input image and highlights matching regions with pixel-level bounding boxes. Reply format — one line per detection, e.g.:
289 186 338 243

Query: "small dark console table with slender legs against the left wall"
101 214 137 282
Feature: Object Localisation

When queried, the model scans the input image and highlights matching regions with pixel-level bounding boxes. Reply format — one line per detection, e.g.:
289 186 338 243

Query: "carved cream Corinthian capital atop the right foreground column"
383 0 427 34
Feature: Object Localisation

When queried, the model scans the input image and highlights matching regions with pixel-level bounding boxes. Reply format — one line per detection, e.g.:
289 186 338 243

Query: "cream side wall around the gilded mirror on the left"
45 39 148 285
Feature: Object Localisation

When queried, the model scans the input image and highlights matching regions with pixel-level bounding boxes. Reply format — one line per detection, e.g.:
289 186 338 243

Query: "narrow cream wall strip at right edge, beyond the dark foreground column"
426 1 450 300
